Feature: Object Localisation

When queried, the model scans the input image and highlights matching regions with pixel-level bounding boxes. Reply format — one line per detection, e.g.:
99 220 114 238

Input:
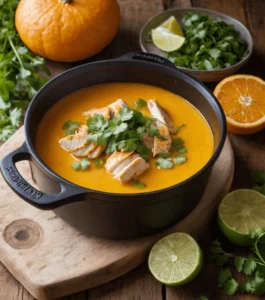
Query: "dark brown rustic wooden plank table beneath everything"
0 0 265 300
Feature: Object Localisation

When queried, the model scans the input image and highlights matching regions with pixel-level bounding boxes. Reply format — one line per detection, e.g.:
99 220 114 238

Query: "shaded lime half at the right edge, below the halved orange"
218 189 265 246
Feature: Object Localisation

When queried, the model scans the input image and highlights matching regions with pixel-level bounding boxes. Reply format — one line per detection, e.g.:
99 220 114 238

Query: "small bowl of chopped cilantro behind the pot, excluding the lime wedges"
140 8 253 82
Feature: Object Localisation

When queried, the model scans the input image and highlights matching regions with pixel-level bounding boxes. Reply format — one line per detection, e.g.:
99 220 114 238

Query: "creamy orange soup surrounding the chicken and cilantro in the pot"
36 83 213 193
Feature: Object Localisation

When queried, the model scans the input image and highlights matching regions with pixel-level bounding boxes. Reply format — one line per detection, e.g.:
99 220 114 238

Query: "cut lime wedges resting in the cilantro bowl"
152 16 185 52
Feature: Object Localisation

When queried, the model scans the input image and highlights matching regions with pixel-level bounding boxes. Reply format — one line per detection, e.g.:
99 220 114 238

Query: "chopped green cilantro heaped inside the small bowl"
168 13 248 70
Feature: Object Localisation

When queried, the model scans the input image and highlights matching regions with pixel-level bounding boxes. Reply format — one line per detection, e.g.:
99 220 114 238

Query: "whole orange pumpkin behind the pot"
15 0 120 62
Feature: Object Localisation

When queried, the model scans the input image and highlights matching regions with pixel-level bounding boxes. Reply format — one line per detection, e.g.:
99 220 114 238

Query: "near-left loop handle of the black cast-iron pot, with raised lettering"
0 143 84 209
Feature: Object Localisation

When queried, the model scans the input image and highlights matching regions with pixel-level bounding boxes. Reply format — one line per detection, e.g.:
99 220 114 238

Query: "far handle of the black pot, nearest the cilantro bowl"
118 52 176 69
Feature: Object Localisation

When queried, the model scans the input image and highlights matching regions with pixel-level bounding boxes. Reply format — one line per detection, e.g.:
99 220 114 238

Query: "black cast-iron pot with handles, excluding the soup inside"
1 52 226 238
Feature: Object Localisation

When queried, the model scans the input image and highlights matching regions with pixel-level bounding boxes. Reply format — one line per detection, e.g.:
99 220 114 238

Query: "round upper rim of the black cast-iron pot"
24 57 227 198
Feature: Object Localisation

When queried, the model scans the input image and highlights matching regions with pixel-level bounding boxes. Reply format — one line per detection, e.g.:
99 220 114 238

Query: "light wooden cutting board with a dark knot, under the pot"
0 128 234 300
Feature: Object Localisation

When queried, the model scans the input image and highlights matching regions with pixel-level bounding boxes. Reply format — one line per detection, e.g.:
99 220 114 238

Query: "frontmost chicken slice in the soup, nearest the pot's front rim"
114 157 149 183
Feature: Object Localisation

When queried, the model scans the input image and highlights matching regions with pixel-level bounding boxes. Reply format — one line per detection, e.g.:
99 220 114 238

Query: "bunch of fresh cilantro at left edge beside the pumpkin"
0 0 50 141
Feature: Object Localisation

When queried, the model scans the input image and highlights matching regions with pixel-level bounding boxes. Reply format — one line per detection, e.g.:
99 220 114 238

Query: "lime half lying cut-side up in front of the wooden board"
148 232 203 286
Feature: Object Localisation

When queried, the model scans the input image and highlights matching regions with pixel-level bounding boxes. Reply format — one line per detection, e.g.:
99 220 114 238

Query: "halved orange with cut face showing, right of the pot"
214 74 265 134
